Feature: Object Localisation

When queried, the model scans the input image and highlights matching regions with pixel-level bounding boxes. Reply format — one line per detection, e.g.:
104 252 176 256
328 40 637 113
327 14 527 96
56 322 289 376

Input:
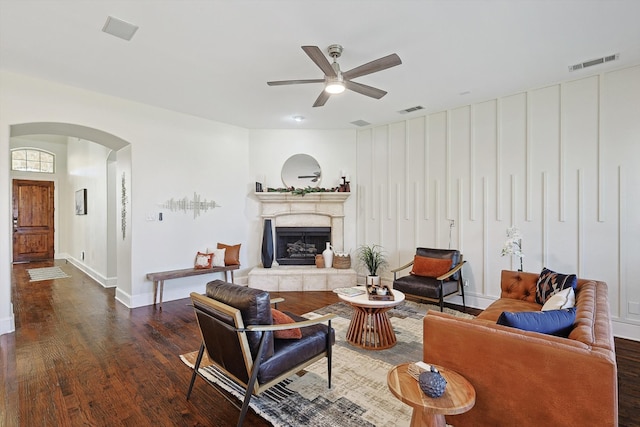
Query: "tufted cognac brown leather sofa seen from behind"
423 271 618 427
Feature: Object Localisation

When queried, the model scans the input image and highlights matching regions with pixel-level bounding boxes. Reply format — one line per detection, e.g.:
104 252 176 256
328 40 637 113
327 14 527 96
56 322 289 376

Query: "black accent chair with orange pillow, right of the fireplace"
391 248 467 311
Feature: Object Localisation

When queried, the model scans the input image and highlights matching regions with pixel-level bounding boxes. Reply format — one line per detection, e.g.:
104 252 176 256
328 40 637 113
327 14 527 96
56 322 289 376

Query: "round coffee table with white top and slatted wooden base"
338 290 404 350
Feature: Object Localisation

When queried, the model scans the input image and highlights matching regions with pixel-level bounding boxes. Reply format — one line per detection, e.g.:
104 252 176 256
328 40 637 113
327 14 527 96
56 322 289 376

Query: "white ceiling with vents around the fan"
0 0 640 129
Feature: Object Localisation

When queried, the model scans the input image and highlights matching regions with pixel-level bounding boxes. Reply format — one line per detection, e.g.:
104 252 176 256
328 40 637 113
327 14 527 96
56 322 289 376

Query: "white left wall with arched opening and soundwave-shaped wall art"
0 72 250 333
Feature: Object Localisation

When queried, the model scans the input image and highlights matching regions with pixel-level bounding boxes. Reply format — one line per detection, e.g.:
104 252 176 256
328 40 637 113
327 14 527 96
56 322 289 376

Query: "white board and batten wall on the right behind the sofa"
357 66 640 339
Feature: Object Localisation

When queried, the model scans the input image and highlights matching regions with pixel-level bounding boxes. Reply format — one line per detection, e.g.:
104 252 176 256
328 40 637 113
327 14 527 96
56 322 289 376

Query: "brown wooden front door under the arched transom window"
13 179 54 262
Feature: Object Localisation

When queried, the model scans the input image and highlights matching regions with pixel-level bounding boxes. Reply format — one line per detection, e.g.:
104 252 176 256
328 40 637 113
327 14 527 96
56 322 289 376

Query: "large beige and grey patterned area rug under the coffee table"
180 301 473 427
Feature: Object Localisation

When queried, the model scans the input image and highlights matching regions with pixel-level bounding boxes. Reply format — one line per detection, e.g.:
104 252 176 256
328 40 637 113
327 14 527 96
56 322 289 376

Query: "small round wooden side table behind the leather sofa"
387 363 476 427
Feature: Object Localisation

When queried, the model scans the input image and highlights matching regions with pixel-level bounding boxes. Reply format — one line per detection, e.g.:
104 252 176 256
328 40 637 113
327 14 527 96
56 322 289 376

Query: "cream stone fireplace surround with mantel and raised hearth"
248 192 357 292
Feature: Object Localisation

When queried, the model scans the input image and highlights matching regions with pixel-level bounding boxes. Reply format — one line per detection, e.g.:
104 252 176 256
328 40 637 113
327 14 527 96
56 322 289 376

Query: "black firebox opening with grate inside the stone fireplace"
275 227 331 265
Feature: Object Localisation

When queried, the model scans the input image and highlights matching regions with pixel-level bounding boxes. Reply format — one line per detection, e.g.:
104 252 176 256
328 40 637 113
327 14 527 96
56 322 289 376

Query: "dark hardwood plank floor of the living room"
0 261 640 427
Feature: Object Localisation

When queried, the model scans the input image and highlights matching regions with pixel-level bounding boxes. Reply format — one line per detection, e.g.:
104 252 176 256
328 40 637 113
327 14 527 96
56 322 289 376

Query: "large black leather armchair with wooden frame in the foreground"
187 280 335 426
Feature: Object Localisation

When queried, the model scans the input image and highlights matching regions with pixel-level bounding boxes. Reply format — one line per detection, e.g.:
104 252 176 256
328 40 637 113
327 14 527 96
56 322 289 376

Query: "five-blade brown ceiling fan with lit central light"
267 44 402 107
